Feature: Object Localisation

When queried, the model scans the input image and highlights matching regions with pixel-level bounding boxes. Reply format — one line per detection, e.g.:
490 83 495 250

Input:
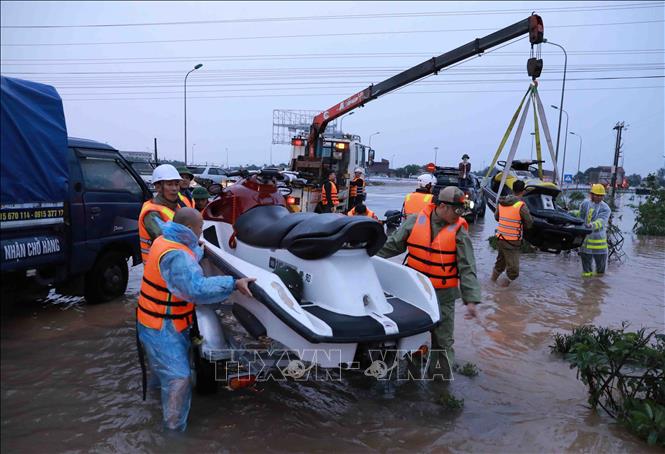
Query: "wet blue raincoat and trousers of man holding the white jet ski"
137 222 235 431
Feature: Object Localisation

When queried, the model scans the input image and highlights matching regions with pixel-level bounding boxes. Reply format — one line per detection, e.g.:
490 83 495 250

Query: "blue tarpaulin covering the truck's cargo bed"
0 77 68 206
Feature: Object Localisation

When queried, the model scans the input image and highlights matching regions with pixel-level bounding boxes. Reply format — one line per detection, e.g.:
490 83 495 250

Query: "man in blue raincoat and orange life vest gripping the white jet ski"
136 208 255 431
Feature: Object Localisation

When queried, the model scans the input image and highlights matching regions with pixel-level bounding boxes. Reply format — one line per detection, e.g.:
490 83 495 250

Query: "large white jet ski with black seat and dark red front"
197 169 439 380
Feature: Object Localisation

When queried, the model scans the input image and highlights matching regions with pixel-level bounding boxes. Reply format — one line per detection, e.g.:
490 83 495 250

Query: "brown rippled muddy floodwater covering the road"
1 184 665 453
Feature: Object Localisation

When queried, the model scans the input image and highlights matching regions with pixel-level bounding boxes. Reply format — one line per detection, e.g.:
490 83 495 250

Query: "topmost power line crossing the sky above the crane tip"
2 2 664 29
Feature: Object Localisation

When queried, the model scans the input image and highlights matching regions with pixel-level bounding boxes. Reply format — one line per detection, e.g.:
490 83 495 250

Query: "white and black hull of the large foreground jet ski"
203 215 439 367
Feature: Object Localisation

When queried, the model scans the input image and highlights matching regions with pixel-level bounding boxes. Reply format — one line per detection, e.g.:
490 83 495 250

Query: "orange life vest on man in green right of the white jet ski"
406 205 464 289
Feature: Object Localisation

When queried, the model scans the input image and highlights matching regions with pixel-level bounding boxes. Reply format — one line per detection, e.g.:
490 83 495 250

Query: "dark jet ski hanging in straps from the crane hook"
482 160 591 252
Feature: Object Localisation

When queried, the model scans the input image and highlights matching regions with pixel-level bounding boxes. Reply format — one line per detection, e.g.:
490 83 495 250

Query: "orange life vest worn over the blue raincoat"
137 236 195 332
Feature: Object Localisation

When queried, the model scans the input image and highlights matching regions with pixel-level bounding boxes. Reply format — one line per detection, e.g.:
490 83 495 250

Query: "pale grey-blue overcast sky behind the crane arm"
1 1 665 175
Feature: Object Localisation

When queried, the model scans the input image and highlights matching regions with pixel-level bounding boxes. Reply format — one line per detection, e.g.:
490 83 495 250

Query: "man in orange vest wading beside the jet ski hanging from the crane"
492 180 533 287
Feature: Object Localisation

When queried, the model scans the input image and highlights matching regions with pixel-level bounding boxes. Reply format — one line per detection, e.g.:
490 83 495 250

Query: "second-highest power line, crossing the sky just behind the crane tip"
0 19 665 47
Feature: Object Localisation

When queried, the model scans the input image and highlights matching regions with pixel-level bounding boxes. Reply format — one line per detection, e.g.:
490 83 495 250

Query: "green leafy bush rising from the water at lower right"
550 324 665 446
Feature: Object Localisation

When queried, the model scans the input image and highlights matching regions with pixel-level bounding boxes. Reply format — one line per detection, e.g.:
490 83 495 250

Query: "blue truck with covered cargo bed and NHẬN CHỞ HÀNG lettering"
0 77 152 303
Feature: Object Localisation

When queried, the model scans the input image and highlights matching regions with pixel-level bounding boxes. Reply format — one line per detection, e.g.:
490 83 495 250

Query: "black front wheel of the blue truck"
84 251 129 303
